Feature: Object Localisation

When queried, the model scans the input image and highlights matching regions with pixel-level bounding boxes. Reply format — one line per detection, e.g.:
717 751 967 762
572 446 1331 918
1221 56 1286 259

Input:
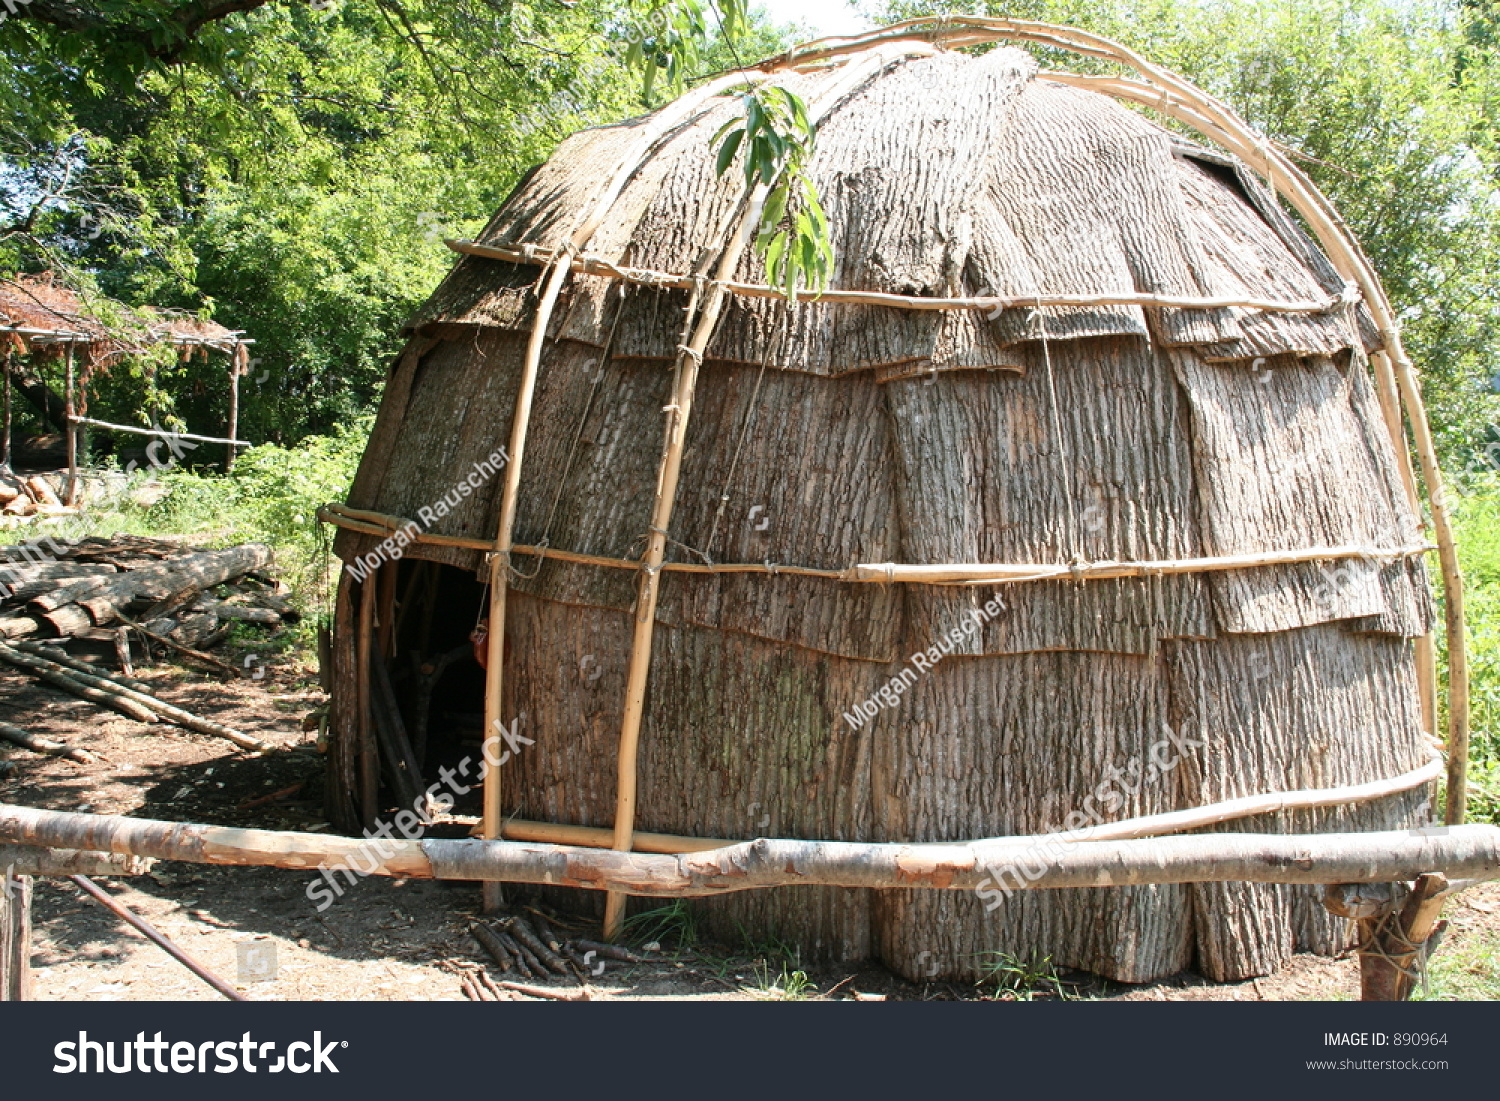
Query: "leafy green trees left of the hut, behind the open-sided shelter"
0 0 663 443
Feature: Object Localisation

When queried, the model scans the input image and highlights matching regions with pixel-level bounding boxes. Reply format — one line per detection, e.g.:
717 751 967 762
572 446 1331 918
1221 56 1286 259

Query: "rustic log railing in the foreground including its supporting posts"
0 804 1500 1001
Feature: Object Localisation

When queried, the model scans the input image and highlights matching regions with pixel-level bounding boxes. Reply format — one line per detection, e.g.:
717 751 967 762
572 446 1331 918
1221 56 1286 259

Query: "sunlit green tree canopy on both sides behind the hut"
0 0 1500 465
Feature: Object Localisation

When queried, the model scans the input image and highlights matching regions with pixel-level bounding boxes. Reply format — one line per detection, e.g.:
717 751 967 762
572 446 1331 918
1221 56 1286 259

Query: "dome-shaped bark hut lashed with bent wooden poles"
324 21 1461 981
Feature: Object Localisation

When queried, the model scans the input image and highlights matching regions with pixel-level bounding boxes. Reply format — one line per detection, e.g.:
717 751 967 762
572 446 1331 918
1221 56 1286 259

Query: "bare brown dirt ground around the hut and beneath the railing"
0 654 1500 1001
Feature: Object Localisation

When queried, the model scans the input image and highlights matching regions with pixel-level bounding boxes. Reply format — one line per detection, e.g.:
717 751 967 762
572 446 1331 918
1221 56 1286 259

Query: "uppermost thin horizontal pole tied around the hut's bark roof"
446 240 1358 314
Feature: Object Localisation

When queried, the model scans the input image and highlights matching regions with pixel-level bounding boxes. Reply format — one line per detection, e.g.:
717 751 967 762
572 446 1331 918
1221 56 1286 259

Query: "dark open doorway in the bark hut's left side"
383 558 486 815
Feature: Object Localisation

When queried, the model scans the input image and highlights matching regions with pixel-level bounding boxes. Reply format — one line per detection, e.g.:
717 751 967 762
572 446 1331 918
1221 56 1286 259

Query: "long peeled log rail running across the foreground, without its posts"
0 804 1500 897
